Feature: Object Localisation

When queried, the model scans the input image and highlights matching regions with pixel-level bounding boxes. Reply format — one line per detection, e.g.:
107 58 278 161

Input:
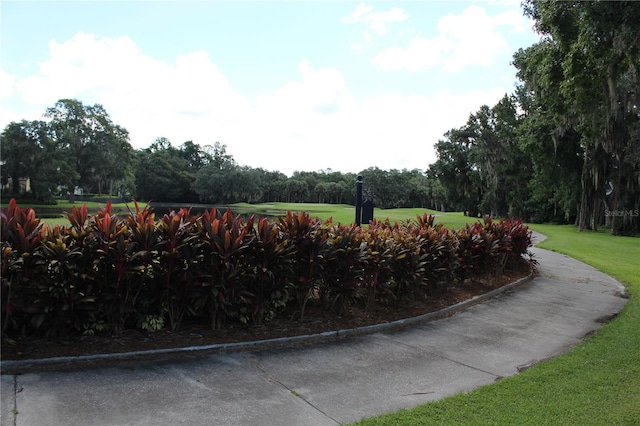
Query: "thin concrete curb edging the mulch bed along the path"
0 273 534 375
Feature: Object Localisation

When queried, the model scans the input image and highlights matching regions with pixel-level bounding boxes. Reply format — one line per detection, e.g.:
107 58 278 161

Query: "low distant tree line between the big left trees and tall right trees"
125 131 442 208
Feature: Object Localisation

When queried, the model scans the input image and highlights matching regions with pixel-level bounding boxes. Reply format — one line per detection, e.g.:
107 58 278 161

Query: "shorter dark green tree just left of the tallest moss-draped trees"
430 95 532 217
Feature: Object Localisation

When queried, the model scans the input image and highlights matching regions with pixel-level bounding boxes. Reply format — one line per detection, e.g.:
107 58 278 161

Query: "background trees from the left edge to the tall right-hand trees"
1 99 435 208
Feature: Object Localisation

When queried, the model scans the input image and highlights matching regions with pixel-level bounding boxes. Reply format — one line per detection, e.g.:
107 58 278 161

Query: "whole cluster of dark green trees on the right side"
427 0 640 235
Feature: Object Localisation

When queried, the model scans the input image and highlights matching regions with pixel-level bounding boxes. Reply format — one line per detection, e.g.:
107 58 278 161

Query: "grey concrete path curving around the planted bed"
0 235 626 426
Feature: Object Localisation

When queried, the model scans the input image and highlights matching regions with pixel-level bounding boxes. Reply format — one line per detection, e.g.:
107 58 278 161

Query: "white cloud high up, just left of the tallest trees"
372 5 523 72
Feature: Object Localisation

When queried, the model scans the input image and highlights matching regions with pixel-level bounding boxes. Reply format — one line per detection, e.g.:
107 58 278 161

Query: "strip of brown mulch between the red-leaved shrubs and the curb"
2 260 531 360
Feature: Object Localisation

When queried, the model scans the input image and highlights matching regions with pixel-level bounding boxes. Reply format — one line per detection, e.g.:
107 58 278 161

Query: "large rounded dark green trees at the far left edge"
3 99 134 198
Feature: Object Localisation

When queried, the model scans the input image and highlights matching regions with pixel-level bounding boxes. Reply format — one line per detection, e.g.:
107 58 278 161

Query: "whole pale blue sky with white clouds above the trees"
0 0 539 176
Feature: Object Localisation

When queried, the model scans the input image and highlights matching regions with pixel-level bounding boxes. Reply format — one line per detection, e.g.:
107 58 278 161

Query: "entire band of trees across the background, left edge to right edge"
0 0 640 234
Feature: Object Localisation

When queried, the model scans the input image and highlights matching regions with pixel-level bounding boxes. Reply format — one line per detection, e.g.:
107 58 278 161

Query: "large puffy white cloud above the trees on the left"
10 33 251 147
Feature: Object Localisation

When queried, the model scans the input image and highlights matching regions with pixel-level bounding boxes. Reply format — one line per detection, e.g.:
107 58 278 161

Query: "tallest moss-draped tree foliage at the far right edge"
514 0 640 235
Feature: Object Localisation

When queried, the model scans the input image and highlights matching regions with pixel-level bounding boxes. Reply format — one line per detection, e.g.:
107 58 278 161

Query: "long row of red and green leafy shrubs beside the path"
1 200 531 338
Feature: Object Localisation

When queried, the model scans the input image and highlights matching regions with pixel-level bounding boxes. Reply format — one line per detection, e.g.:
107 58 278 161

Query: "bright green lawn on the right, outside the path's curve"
356 225 640 426
